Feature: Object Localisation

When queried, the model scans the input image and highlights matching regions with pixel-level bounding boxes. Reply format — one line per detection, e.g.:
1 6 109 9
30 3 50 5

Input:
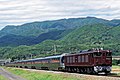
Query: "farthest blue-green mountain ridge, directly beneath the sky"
0 17 119 37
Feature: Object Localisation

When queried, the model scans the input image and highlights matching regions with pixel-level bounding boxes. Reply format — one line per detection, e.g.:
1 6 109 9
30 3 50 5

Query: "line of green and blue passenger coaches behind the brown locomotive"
6 54 64 70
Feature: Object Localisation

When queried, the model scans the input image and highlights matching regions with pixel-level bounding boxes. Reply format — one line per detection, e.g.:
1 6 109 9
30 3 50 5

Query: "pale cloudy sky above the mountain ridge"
0 0 120 29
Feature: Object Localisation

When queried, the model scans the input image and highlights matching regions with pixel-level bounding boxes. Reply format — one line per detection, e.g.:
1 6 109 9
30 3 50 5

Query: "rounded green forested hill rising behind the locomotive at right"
61 24 120 55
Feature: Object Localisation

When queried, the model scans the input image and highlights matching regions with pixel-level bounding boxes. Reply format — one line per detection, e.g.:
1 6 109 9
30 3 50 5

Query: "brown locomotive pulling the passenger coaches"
64 49 112 73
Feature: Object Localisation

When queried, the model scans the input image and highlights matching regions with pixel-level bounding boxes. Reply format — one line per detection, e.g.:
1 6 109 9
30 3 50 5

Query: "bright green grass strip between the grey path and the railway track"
5 68 83 80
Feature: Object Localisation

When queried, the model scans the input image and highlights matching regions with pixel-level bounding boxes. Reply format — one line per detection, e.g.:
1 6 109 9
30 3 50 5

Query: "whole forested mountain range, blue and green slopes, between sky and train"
0 17 120 59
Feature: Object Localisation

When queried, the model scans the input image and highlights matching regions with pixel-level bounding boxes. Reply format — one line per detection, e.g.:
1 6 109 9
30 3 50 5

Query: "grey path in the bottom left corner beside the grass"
0 67 25 80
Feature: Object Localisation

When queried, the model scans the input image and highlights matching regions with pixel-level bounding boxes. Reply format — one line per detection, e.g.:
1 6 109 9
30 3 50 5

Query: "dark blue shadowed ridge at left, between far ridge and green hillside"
0 29 71 47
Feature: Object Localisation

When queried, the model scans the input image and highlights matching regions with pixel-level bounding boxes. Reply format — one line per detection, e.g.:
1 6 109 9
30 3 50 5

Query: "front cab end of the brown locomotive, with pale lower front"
93 50 112 73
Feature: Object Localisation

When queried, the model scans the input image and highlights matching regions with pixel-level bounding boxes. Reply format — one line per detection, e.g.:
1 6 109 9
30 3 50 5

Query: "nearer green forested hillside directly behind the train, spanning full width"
0 24 120 59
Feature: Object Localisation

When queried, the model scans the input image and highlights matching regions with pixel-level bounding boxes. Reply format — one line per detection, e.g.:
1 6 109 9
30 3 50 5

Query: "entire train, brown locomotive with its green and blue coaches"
6 49 112 74
